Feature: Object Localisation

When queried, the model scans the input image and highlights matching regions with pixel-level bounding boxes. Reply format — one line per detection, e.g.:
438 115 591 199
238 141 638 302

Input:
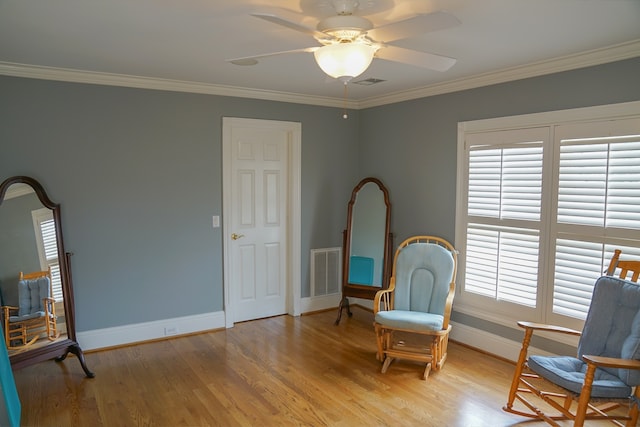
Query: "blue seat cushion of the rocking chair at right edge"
527 356 631 399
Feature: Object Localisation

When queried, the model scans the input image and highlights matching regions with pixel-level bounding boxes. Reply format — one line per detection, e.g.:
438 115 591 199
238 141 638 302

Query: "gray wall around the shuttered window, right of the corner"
359 58 640 352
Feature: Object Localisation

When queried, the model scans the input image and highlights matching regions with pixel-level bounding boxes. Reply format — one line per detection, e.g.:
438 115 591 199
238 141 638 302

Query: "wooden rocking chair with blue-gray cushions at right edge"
503 250 640 426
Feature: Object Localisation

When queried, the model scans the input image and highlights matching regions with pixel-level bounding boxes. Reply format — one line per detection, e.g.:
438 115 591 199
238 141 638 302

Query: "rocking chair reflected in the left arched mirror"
2 267 58 349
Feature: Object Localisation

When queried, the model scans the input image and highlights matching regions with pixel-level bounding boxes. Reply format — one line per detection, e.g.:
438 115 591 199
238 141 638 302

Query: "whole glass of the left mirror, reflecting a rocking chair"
0 183 67 355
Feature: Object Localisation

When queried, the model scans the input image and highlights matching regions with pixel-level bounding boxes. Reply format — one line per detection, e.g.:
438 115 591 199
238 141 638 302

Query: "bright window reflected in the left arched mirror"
31 208 63 302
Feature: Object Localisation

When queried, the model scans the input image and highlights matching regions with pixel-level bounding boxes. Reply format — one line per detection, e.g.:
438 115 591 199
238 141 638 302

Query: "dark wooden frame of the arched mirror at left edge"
0 176 95 378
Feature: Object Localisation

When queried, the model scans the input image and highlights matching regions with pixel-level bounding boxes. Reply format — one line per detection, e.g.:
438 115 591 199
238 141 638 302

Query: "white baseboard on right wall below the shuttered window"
451 322 552 362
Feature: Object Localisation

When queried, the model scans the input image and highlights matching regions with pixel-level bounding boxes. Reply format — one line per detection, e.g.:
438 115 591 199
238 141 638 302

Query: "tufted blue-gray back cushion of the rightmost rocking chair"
578 276 640 387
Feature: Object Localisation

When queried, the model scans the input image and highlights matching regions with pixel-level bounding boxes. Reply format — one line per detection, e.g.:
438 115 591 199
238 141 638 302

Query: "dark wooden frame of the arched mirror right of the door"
335 177 393 325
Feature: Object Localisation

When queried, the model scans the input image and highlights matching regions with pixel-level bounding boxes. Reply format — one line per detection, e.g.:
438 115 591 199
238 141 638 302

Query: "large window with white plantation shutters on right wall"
456 103 640 327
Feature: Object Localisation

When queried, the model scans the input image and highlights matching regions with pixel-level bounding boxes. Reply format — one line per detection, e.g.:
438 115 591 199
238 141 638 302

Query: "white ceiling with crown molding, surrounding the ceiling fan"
0 0 640 106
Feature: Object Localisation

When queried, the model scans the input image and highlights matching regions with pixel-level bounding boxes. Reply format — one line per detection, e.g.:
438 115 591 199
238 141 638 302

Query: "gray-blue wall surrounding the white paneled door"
0 76 360 332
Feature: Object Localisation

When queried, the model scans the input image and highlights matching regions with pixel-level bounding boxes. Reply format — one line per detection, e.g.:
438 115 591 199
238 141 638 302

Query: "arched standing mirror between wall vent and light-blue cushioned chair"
335 177 393 325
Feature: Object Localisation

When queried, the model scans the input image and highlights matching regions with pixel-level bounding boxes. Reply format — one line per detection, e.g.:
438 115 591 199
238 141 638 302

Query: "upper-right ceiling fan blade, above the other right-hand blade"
367 11 460 43
